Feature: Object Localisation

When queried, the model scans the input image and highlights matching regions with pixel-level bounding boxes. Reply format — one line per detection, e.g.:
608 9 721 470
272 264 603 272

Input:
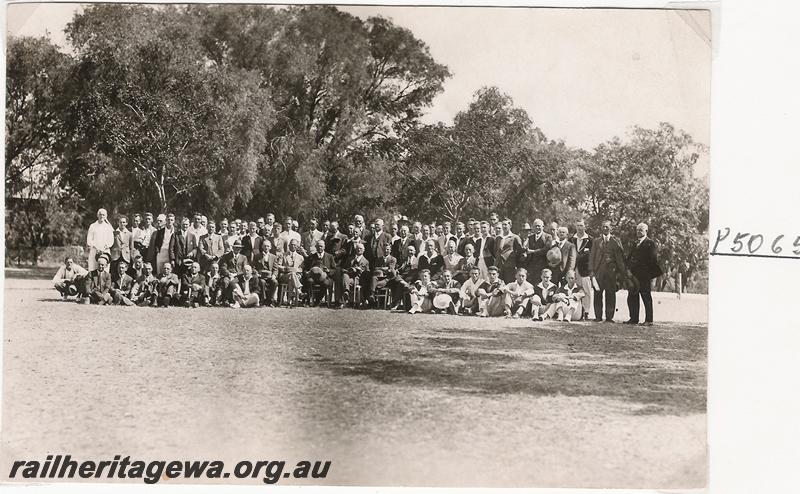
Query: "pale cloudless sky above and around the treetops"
7 4 711 176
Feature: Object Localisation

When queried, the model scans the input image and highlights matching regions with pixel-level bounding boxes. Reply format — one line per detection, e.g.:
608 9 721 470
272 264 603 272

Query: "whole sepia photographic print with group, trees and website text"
0 3 708 490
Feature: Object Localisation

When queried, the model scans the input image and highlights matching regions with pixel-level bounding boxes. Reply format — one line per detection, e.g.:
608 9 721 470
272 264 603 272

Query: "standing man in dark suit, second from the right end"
589 221 625 322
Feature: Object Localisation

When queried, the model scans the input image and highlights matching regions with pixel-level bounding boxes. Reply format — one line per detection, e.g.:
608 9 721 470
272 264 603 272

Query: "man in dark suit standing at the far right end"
626 223 663 326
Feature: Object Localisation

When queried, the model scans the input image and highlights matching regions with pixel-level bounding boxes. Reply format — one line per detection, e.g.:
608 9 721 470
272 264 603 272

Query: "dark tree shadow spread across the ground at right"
307 328 706 415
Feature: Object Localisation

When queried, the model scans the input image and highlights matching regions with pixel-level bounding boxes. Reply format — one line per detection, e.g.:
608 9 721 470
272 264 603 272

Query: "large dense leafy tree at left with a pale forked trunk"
67 5 273 212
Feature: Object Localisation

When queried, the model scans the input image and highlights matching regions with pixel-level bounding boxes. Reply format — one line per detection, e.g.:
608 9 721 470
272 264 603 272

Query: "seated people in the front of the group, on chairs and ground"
53 242 585 321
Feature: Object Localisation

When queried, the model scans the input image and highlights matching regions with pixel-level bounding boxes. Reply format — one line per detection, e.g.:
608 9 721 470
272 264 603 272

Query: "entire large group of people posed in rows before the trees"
53 209 662 325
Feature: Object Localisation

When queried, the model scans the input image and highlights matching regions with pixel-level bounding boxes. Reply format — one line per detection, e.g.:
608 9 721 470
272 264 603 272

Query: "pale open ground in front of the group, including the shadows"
0 278 707 488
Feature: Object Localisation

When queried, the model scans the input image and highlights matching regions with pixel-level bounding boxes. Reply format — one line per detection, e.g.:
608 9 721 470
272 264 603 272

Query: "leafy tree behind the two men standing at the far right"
584 123 708 286
